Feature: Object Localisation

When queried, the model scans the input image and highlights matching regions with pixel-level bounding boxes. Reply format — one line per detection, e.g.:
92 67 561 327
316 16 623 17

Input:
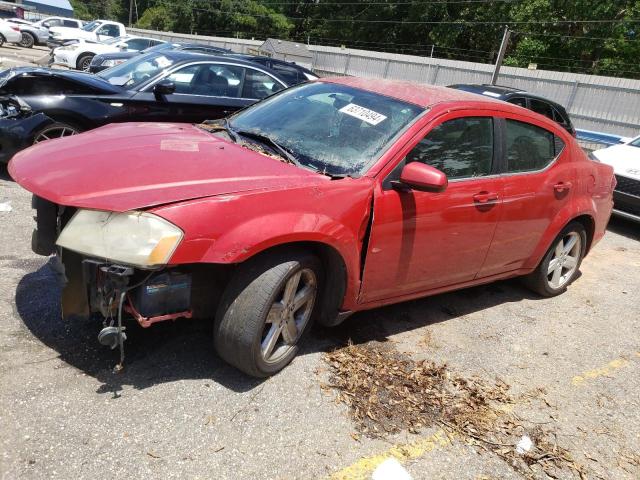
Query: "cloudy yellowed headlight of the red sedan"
56 210 184 268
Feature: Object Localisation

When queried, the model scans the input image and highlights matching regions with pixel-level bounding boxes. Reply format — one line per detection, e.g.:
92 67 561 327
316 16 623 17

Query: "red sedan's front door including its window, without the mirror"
360 112 503 302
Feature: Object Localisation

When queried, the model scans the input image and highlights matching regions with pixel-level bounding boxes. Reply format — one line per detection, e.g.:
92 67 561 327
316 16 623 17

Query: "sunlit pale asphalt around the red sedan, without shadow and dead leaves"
0 47 640 480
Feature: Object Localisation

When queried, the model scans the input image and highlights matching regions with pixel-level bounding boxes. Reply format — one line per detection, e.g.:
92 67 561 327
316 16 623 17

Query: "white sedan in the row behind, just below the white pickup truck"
53 35 161 71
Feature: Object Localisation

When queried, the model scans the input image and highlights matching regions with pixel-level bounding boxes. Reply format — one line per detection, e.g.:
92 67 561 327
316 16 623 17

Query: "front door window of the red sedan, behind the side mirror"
406 117 493 179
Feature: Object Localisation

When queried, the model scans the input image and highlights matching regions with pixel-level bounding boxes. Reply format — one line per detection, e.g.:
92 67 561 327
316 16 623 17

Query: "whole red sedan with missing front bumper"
9 78 615 376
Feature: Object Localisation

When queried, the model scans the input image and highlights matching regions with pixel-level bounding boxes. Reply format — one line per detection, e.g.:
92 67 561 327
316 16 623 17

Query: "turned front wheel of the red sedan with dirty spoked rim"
214 252 322 377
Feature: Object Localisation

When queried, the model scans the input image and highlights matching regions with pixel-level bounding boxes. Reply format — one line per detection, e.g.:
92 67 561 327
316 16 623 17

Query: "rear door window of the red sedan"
506 120 564 173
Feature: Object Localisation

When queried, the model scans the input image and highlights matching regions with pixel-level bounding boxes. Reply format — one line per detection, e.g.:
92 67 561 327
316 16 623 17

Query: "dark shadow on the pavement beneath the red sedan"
16 260 537 397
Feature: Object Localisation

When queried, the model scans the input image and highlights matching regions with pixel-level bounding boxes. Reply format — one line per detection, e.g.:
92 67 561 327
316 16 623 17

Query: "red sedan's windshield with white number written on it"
229 82 423 176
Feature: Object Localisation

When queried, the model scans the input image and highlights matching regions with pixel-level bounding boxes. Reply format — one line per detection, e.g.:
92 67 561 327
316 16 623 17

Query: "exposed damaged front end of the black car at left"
0 95 55 163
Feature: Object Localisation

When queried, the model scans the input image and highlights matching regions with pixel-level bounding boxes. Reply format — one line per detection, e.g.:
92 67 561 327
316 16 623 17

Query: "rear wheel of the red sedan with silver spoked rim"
522 222 587 297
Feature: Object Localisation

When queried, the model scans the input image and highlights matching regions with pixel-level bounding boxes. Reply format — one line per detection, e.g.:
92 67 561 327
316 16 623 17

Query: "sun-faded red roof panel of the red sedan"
319 77 508 109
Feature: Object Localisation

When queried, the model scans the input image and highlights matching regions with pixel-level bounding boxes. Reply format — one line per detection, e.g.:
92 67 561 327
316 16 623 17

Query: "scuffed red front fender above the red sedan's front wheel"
151 177 373 306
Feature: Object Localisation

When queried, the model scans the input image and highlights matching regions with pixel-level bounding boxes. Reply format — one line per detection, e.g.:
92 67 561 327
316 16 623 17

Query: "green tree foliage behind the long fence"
72 0 640 78
